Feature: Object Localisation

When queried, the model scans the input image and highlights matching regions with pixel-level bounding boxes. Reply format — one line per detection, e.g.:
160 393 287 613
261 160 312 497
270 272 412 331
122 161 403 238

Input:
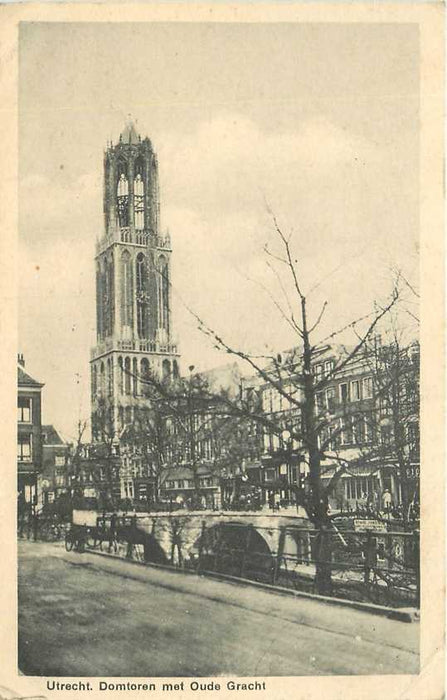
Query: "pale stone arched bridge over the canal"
73 508 311 580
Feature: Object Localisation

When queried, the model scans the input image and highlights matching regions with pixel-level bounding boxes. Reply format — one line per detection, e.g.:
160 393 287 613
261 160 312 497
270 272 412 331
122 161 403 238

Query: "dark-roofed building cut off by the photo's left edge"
17 355 44 511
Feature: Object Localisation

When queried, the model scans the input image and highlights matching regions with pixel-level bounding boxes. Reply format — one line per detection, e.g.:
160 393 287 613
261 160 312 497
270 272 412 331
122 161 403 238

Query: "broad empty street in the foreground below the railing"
18 541 419 677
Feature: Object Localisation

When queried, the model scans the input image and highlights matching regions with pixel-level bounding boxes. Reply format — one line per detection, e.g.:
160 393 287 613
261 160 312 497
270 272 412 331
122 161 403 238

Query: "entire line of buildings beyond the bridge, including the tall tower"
18 122 419 510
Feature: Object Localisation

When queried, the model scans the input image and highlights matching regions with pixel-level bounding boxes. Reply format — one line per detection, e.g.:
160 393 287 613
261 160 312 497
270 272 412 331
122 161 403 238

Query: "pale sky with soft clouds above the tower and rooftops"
19 23 419 439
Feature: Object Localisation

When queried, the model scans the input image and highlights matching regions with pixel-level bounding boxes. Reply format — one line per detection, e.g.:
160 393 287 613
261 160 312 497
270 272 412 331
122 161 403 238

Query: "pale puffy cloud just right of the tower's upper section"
159 114 378 216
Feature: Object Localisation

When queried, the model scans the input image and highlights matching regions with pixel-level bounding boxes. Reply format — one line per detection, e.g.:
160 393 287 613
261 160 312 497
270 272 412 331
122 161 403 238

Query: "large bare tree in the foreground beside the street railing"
187 216 399 593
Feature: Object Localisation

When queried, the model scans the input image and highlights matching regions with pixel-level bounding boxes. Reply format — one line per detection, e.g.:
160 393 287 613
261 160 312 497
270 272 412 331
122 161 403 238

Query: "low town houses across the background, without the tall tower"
18 336 420 510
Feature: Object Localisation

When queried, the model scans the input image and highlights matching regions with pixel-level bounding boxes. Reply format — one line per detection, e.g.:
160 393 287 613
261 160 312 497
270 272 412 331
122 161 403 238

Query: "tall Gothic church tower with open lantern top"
91 122 178 441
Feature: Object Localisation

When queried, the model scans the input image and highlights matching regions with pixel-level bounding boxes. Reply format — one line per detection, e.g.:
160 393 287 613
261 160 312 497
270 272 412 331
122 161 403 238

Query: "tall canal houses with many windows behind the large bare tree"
260 338 420 511
